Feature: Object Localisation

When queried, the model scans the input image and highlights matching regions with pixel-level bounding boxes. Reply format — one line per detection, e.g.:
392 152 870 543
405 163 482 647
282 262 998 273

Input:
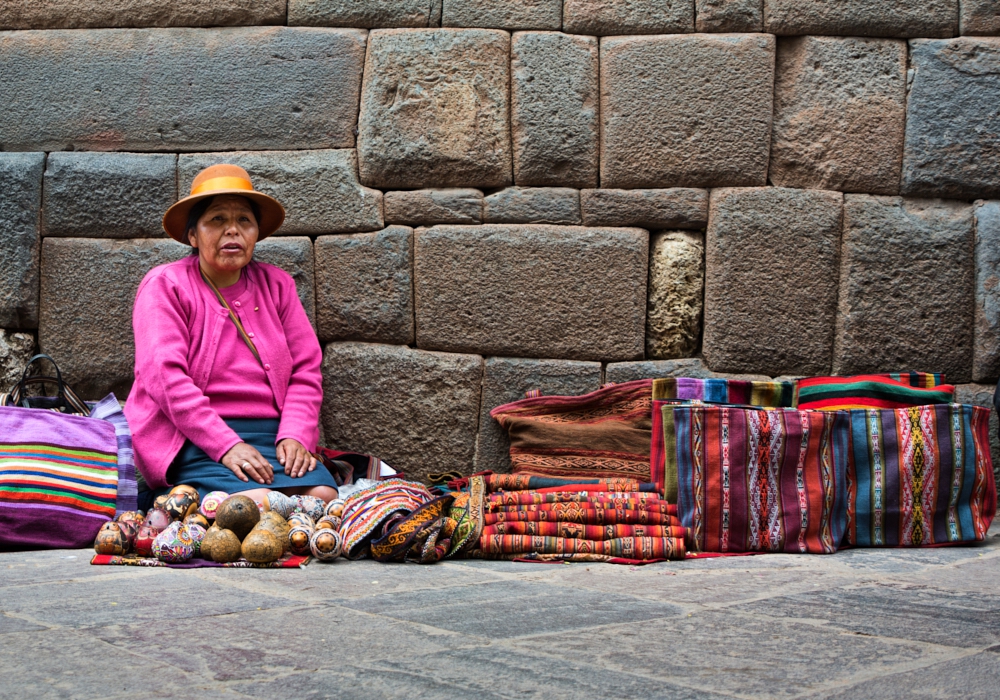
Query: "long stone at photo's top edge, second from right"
764 0 958 38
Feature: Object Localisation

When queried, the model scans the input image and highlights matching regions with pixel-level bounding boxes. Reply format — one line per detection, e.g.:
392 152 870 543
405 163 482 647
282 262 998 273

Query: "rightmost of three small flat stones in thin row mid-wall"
580 187 708 229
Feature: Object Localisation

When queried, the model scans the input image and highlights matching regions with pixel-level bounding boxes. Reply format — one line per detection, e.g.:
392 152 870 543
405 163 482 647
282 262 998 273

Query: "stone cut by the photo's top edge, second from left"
288 0 441 29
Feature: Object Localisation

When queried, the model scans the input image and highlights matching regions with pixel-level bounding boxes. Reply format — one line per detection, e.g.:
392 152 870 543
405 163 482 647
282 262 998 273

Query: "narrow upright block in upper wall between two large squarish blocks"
510 32 600 187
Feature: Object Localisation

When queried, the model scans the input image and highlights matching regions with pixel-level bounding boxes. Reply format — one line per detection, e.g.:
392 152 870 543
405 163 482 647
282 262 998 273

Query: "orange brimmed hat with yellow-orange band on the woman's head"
163 165 285 243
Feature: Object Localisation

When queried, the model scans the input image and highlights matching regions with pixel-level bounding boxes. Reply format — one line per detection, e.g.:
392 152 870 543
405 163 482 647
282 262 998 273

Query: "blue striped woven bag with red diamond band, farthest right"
846 404 997 547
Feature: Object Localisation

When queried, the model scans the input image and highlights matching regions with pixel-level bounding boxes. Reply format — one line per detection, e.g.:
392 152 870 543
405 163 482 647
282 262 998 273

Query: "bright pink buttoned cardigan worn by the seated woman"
125 255 323 489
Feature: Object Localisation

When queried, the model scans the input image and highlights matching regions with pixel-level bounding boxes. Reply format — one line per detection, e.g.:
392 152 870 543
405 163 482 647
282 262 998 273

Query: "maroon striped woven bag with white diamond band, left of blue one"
652 404 850 554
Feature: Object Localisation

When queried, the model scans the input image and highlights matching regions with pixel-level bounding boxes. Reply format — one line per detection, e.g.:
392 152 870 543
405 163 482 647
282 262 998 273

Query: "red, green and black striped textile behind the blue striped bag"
796 373 955 411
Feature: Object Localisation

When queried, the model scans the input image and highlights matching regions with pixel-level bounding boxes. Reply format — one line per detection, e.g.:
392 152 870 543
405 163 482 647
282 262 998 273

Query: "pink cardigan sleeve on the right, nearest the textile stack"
278 278 323 452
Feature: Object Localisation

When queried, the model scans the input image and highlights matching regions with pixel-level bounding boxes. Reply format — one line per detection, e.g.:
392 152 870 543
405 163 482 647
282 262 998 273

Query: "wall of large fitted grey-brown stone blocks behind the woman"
0 0 1000 476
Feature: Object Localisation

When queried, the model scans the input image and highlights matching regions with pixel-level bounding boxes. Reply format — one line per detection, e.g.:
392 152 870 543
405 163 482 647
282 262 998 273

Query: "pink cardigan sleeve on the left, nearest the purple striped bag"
132 274 241 462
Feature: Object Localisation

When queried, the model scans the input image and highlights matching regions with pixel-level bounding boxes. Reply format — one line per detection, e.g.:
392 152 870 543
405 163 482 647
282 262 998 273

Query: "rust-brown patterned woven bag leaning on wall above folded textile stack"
490 380 652 482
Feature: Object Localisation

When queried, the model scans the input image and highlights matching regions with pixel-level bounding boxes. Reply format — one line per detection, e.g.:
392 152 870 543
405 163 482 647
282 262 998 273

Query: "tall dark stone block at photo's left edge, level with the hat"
0 153 45 328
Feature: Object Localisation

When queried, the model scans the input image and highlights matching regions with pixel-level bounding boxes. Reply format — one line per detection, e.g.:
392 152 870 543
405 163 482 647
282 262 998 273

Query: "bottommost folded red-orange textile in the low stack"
479 535 685 560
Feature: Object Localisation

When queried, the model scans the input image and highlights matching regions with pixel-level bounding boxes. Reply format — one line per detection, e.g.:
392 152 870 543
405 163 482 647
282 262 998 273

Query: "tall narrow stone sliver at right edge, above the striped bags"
972 201 1000 382
